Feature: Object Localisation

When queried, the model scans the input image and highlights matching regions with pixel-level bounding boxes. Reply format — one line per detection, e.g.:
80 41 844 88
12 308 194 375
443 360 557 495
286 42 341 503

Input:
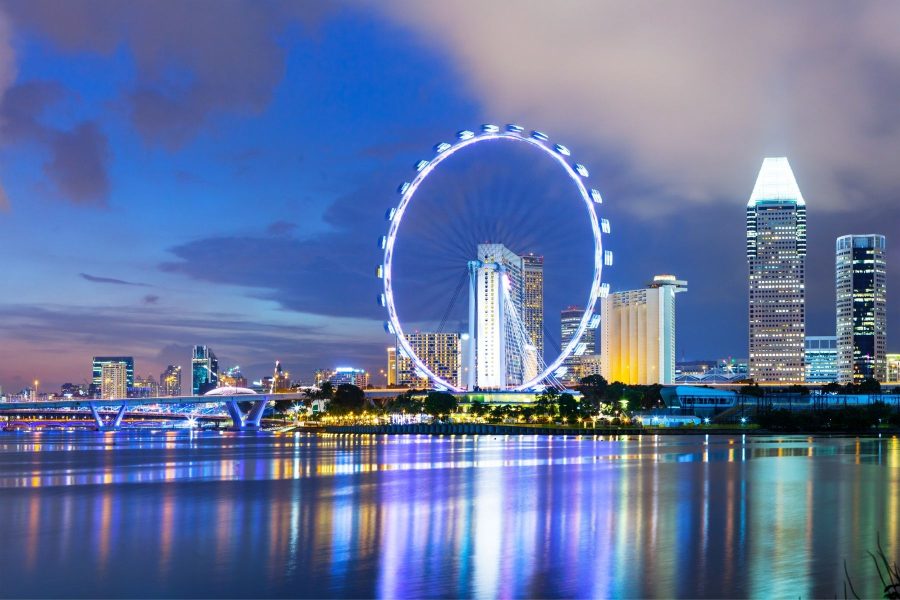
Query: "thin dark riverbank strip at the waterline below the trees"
314 423 900 437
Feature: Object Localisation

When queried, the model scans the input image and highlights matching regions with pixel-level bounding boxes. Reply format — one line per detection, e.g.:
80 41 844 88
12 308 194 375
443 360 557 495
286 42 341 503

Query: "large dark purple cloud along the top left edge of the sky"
7 0 330 148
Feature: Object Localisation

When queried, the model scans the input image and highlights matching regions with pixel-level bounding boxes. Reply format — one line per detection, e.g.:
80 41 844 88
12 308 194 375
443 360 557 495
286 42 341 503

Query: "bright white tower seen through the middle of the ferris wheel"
475 244 536 389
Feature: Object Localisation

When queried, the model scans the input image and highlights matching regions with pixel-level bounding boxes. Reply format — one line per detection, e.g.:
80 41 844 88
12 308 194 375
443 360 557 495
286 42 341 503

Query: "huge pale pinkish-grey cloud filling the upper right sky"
372 0 900 216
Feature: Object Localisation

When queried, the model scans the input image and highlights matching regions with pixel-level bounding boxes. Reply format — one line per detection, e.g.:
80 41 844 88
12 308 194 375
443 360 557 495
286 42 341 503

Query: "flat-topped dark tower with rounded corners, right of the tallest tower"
835 235 887 383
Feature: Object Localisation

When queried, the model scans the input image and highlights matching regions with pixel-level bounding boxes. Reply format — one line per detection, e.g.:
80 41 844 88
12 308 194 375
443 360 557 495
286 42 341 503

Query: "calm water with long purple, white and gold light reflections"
0 432 900 598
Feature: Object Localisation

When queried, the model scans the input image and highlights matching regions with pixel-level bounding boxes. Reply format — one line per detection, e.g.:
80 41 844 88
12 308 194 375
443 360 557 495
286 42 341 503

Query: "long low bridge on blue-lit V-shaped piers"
0 393 307 431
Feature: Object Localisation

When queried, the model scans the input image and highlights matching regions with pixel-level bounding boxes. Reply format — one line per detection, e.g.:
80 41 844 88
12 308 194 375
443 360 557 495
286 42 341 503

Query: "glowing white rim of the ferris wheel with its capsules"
377 124 612 392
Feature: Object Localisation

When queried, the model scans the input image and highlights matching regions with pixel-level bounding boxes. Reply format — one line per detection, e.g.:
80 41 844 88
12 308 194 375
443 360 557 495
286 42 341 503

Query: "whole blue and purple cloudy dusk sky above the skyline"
0 0 900 392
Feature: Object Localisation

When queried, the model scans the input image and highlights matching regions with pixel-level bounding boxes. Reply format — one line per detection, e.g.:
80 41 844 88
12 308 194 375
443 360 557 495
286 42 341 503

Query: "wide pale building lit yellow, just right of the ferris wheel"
600 275 687 385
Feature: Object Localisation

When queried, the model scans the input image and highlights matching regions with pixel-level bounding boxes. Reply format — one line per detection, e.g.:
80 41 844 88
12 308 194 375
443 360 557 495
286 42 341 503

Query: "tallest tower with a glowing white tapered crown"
747 157 806 383
